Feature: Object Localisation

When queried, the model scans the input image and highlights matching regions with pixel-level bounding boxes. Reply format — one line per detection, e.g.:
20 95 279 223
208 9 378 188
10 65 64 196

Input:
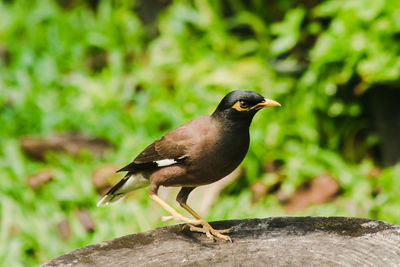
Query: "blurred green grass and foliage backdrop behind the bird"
0 0 400 266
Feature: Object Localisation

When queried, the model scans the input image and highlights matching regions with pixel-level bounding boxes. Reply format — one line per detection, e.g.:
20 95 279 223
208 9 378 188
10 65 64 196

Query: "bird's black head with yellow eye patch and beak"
212 90 280 125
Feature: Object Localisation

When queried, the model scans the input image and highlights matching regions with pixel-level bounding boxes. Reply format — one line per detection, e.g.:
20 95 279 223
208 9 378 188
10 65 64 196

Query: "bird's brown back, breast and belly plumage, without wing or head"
149 116 249 186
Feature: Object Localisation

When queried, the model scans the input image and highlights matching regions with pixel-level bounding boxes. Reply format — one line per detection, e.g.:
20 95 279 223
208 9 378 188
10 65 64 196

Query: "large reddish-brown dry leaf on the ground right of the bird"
285 174 339 213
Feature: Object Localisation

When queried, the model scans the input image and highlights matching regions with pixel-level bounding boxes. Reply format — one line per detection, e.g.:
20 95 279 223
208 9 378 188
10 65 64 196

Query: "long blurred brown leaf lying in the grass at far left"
20 132 111 161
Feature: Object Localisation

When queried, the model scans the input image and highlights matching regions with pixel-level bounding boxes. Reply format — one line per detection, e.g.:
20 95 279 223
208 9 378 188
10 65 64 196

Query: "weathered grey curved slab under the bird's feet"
42 217 400 266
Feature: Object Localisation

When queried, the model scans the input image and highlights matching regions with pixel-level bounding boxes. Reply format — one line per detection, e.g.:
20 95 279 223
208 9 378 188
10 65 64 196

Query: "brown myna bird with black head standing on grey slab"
97 90 280 241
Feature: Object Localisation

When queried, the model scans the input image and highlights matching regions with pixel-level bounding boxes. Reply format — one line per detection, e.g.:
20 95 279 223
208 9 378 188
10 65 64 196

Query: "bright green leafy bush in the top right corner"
311 0 400 86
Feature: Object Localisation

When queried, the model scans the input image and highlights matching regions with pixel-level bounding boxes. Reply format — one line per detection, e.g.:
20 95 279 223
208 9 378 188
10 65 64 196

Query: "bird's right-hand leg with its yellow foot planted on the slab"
176 187 232 242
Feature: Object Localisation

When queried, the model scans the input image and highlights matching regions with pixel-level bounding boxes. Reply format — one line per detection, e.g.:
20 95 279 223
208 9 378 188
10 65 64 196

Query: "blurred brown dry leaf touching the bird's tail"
92 164 118 195
